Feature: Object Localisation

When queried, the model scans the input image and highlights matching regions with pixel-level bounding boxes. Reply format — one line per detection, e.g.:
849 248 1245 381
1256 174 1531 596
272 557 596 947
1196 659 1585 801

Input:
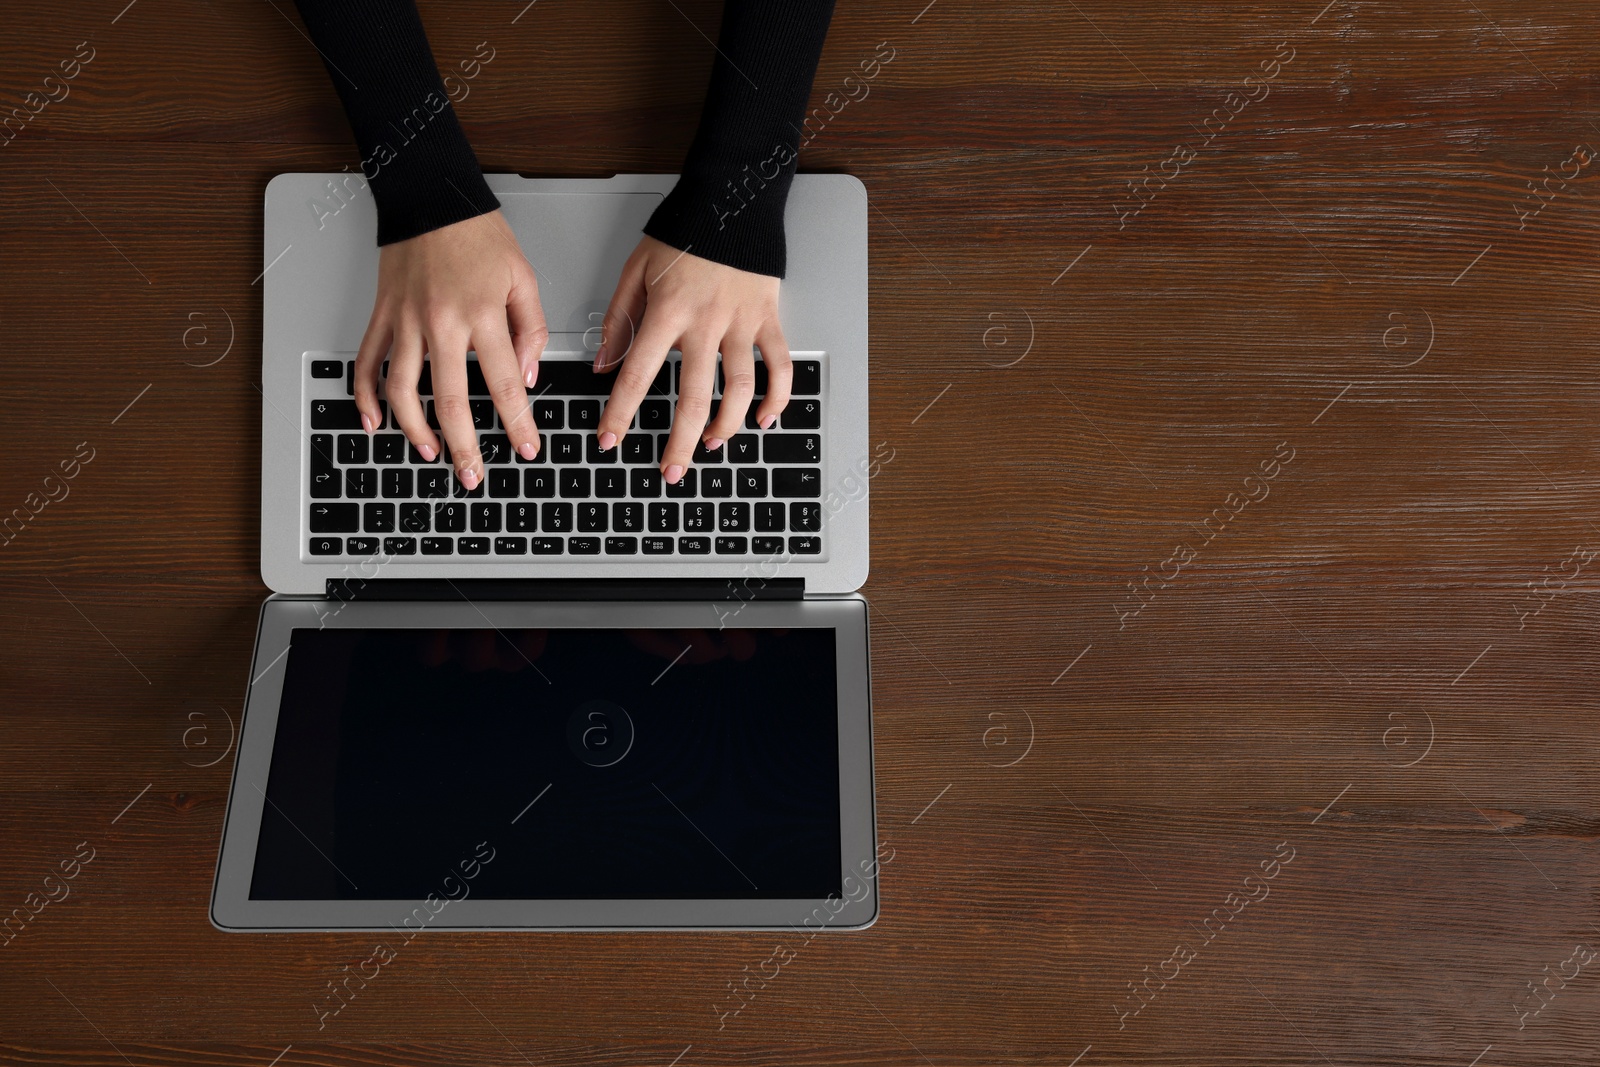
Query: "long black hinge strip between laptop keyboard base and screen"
326 577 805 601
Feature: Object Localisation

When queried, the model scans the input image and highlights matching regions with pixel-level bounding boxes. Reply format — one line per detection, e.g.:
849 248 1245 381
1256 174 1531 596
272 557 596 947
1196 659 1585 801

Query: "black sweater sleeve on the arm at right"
645 0 834 278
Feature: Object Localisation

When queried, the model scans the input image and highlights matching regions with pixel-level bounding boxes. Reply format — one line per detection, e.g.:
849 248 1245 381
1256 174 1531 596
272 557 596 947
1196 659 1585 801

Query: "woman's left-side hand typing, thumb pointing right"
355 211 550 490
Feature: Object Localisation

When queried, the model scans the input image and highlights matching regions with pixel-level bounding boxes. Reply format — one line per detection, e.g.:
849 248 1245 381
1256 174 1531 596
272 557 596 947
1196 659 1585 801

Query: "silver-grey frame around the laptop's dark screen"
211 597 878 931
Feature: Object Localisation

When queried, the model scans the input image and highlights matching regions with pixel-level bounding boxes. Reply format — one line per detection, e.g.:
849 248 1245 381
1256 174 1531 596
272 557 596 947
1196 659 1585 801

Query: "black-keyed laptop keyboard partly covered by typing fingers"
304 352 822 563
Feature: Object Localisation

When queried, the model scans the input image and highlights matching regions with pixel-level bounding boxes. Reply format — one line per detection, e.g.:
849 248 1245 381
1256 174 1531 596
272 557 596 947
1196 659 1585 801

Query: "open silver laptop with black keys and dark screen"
211 173 893 939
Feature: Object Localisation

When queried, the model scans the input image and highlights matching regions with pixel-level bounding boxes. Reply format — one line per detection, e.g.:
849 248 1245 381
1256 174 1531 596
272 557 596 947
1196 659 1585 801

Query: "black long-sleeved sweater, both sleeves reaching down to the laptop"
294 0 834 277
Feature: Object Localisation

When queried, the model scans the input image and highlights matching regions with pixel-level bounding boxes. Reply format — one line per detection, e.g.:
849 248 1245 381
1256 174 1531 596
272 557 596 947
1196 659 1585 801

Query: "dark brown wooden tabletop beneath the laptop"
0 0 1600 1067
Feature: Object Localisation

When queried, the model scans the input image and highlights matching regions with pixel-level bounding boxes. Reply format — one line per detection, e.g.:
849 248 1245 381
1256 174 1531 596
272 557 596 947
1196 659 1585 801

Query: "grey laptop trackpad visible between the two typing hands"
499 192 662 336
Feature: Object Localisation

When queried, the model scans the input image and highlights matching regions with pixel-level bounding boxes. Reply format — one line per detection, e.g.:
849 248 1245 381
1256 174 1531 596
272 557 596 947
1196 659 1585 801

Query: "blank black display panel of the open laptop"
250 627 842 901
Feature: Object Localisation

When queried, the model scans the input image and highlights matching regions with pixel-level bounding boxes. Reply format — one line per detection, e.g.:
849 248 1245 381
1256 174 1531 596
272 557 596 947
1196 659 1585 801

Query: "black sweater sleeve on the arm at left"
294 0 499 245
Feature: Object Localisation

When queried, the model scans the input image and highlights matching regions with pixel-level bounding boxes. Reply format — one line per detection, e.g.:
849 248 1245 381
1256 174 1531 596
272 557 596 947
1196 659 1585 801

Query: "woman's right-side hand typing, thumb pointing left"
592 237 794 482
